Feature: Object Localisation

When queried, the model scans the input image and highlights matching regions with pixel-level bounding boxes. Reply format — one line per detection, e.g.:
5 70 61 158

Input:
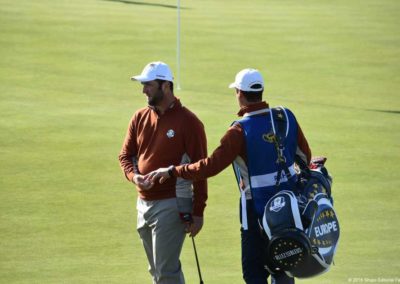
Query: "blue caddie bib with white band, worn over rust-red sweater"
233 109 298 218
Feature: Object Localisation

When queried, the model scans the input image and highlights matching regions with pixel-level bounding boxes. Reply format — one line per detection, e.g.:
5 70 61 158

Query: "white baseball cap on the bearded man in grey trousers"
131 61 174 82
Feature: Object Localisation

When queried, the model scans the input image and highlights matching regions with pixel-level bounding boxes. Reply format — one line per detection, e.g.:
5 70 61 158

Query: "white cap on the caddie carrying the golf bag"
229 68 264 92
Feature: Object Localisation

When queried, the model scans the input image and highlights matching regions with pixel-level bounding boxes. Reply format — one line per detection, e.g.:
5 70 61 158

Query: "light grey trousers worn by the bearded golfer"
137 198 186 284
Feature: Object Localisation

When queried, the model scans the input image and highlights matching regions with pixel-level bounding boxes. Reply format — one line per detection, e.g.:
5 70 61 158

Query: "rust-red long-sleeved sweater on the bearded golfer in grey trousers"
119 99 207 216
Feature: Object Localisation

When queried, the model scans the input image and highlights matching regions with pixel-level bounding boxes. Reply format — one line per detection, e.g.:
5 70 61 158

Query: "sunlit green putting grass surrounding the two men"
0 0 400 284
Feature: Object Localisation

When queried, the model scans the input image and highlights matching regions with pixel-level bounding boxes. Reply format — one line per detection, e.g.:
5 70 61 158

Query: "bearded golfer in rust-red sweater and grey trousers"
119 62 207 284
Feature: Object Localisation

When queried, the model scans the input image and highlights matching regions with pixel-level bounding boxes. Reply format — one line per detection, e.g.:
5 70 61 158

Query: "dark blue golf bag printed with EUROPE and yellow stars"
262 158 340 278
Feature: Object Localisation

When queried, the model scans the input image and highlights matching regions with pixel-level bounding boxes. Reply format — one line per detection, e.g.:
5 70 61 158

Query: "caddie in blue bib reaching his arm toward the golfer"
145 69 311 284
